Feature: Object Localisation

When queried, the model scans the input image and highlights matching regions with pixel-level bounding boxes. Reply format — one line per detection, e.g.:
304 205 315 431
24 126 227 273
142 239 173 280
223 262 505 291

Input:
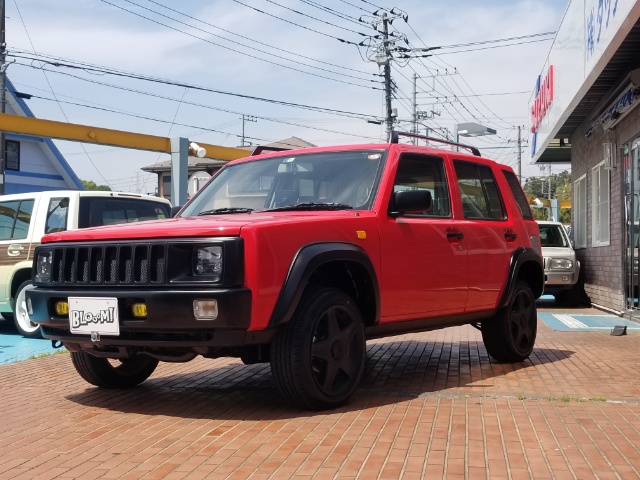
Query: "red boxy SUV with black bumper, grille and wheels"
27 134 544 409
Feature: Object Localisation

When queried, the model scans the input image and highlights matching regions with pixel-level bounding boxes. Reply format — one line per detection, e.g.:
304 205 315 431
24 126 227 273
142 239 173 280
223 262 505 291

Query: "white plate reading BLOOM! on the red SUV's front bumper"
69 297 120 335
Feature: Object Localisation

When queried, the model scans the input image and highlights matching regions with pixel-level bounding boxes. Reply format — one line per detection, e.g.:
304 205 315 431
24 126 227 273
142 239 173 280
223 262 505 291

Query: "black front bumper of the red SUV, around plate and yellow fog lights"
27 287 261 347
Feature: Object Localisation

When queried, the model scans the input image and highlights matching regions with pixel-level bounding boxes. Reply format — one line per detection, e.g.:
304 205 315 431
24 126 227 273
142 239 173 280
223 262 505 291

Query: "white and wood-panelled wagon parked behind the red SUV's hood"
0 190 171 337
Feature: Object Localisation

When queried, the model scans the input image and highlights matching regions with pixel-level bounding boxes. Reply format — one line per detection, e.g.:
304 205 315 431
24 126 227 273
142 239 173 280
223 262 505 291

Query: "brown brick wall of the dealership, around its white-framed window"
571 99 640 312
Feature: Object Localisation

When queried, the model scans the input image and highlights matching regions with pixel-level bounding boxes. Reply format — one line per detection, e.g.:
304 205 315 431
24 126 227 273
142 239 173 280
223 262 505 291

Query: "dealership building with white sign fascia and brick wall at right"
529 0 640 314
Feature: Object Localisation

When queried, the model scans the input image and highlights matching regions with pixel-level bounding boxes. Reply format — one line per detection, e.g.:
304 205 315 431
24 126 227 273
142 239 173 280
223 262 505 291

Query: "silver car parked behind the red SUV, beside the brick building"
538 221 581 306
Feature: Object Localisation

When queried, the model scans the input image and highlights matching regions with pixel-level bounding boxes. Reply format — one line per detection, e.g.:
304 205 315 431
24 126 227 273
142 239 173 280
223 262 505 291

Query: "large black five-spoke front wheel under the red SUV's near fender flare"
271 287 365 410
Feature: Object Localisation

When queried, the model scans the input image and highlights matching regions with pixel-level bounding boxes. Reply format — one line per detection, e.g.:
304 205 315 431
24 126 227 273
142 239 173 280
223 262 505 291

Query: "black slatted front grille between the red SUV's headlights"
51 243 168 286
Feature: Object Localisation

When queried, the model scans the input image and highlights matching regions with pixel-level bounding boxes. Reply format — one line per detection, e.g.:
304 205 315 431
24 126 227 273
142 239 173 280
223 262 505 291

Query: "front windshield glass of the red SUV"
180 150 385 217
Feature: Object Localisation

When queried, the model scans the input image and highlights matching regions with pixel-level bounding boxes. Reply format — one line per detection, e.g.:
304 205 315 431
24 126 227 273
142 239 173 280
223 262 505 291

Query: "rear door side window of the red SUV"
454 160 505 220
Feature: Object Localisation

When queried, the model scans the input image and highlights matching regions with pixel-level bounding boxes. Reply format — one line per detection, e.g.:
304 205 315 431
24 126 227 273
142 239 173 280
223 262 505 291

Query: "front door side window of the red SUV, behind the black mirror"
393 155 451 217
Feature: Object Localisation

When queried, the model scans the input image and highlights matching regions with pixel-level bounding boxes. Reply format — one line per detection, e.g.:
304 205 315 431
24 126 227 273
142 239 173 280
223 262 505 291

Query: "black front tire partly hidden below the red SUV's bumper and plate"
71 351 158 388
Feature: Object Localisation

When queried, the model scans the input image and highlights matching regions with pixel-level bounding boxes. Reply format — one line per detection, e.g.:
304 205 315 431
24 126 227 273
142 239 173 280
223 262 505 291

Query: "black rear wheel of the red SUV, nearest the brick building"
482 281 538 363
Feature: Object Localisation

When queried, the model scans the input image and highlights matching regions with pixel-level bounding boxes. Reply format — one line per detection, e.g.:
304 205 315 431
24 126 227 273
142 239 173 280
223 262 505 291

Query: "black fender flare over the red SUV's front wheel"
269 242 380 327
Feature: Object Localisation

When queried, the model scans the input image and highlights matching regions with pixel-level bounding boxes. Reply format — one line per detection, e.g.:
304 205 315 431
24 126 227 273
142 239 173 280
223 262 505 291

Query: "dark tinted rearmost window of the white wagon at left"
78 197 170 228
